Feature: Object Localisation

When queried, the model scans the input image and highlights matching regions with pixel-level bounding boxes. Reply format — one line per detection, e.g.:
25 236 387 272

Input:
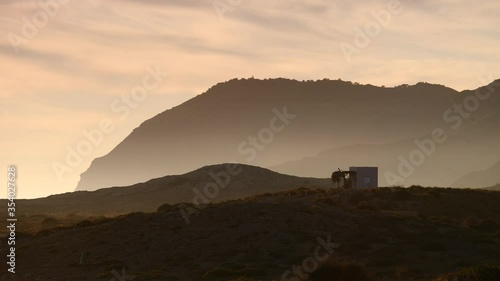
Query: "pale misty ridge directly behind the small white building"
270 132 500 187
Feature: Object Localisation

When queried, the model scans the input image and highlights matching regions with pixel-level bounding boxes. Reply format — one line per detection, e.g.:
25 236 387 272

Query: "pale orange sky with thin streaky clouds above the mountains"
0 0 500 198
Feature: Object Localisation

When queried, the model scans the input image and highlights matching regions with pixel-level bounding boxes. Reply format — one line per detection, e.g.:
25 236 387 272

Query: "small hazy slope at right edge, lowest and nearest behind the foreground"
453 162 500 188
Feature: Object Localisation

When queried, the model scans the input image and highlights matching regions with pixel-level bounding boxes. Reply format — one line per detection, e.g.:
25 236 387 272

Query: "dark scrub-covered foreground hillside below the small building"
5 187 500 281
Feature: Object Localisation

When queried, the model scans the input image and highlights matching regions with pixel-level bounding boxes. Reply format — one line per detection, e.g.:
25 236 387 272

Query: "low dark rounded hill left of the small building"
15 164 333 213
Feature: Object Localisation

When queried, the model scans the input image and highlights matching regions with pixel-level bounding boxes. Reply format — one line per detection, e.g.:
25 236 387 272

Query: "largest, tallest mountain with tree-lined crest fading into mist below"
77 78 500 190
